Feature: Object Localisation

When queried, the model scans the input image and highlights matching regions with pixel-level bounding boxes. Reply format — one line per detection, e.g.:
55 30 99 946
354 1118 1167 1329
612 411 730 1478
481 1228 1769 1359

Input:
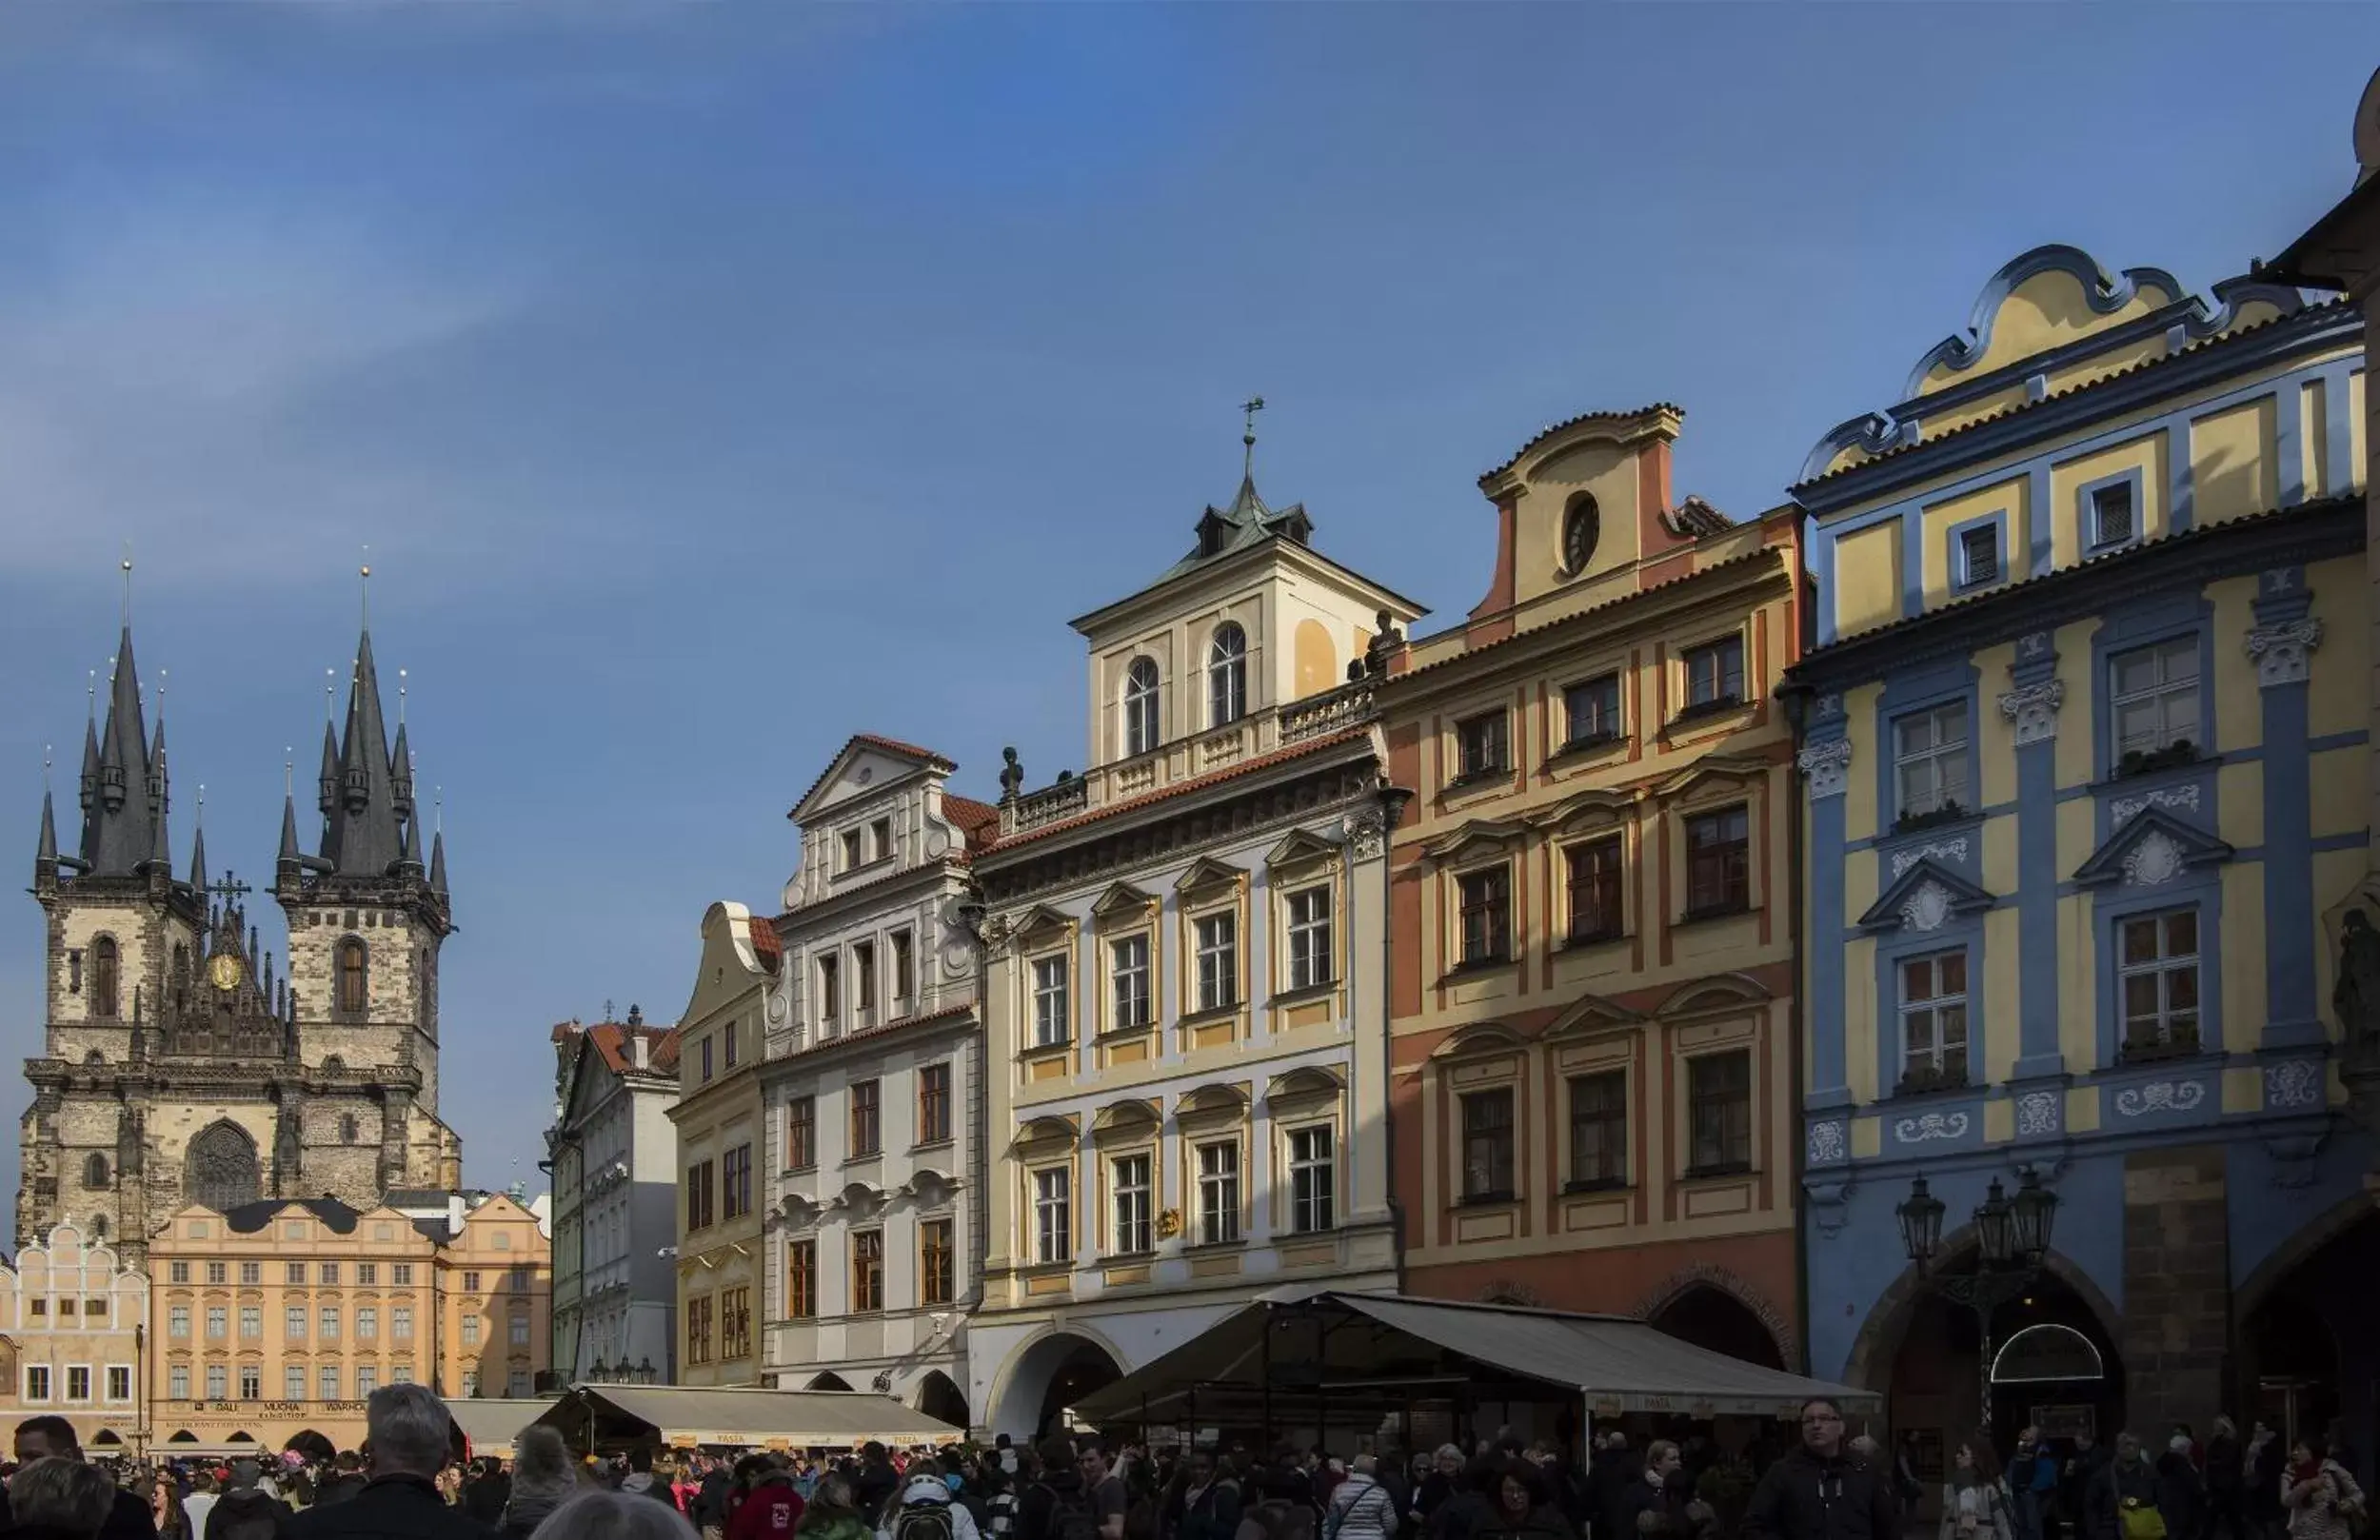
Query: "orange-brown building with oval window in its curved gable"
1383 405 1802 1366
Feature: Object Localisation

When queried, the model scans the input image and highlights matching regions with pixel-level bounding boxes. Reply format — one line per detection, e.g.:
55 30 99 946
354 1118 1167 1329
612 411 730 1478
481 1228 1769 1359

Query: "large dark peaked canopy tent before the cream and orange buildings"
1074 1290 1883 1431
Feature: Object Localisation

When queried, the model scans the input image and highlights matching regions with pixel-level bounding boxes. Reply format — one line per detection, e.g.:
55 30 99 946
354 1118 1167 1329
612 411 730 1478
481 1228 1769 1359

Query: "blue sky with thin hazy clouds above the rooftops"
0 5 2380 1209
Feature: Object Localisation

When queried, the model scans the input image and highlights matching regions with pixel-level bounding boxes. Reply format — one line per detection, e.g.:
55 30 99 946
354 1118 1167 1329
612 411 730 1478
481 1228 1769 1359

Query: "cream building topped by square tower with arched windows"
969 464 1421 1435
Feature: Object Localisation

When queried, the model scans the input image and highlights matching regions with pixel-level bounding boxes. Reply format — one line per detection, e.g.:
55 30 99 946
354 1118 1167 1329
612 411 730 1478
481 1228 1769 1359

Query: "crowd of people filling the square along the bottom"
0 1385 2369 1540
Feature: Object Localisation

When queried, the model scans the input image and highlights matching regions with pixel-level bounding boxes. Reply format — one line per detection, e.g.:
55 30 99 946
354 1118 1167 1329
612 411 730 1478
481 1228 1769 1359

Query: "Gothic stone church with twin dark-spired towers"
17 628 462 1269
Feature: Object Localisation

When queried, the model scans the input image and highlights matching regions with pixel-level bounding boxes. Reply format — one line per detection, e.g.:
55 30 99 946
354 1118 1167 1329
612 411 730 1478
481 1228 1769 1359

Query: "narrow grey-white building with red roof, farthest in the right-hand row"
545 1009 679 1385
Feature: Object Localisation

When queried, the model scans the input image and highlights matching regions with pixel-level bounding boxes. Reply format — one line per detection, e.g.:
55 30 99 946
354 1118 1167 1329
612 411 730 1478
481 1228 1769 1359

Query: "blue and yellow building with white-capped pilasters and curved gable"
1790 246 2380 1450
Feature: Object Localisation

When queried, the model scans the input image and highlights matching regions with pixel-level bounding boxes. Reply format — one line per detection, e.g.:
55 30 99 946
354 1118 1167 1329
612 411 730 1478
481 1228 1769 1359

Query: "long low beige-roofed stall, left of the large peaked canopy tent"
536 1385 966 1454
